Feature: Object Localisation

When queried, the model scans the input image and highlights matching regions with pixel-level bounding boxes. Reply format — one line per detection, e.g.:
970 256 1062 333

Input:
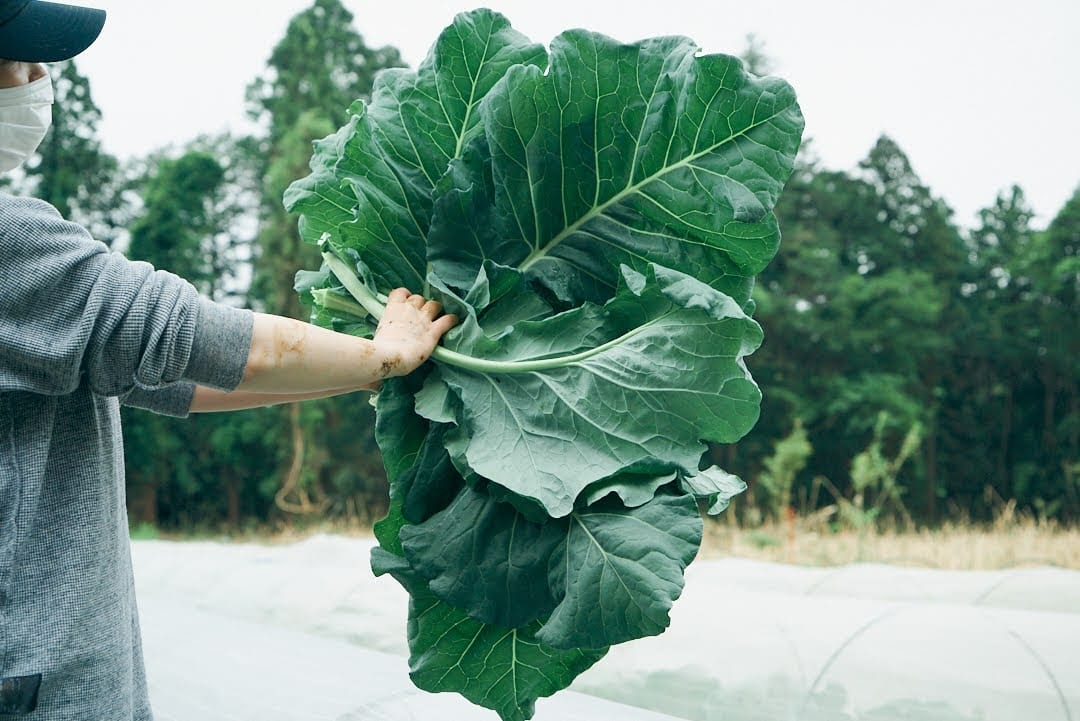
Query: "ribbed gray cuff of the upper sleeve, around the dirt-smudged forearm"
184 298 255 391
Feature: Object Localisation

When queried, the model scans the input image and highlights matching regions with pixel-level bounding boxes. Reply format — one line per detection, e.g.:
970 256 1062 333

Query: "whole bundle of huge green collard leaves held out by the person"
286 10 802 721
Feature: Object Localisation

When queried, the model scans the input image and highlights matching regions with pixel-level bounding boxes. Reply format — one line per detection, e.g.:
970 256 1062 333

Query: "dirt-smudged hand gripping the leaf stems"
375 288 458 378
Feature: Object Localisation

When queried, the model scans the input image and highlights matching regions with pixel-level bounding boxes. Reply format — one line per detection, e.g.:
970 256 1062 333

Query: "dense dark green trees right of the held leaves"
718 138 1080 522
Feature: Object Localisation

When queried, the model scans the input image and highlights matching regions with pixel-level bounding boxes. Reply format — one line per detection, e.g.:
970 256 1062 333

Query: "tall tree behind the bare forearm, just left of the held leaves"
247 0 403 526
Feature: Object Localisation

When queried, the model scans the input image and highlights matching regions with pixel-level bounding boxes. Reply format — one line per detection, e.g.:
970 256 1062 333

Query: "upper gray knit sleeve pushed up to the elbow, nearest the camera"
0 195 253 400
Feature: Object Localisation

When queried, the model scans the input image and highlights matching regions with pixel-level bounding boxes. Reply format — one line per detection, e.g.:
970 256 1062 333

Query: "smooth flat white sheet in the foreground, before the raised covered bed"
143 595 672 721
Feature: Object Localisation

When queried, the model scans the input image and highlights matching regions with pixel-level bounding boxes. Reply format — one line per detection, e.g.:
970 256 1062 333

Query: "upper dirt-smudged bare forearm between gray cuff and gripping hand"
237 313 402 397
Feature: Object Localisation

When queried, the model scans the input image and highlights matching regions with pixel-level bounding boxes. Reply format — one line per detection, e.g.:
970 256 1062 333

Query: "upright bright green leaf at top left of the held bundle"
285 10 546 290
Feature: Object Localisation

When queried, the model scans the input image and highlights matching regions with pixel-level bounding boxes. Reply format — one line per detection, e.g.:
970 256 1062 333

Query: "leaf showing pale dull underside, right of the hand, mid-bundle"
427 267 761 518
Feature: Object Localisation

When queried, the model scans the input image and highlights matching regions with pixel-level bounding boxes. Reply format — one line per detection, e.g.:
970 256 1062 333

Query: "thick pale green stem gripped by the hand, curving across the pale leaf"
323 253 670 375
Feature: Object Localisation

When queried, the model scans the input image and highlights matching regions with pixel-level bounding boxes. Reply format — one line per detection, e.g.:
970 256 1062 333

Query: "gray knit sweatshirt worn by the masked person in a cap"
0 193 252 721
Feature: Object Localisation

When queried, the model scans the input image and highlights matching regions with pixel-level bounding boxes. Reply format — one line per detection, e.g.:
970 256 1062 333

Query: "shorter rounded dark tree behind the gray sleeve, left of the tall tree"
124 146 281 527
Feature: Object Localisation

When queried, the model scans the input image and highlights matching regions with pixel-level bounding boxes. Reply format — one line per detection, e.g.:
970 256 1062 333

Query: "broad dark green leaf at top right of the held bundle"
429 30 802 303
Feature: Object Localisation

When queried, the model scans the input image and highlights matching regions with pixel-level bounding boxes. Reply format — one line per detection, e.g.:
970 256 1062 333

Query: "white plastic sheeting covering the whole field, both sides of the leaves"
134 536 1080 721
